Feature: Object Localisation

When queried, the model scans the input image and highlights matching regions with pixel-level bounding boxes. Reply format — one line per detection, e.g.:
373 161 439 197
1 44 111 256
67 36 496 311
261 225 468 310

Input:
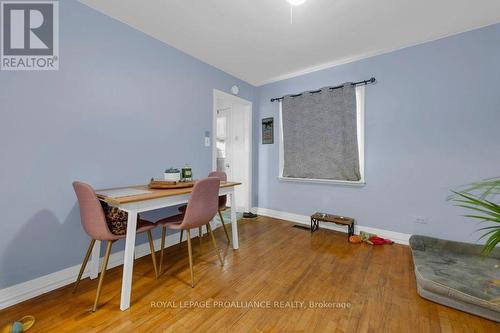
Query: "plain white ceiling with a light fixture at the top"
81 0 500 86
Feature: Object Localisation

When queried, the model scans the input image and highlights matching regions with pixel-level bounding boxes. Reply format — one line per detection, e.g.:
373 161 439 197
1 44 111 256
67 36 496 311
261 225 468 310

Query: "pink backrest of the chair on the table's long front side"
180 177 220 229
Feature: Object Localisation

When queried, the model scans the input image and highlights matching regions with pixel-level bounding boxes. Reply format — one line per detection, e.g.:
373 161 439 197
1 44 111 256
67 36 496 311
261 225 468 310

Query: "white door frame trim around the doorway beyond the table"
212 89 253 212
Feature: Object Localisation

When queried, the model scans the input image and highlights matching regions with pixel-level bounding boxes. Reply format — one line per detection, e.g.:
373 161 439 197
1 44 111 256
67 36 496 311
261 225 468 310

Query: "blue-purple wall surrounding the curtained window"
254 25 500 241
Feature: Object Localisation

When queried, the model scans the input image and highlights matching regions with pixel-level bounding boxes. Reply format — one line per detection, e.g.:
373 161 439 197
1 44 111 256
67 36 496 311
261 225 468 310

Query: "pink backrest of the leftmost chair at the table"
73 182 117 240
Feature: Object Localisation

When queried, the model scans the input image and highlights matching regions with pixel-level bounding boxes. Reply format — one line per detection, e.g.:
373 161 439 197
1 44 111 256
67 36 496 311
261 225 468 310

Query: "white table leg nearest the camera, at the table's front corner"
120 210 137 311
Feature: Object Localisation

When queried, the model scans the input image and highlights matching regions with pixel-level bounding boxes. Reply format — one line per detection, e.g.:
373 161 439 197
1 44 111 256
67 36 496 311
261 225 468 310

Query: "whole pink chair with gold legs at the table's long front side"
157 177 224 287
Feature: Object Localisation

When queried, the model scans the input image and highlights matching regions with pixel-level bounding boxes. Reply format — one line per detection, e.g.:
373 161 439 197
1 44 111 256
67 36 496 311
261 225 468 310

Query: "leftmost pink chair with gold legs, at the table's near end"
73 182 158 311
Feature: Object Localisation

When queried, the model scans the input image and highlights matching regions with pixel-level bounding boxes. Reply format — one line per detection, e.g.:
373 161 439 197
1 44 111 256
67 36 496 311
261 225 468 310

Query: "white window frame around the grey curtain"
278 86 366 186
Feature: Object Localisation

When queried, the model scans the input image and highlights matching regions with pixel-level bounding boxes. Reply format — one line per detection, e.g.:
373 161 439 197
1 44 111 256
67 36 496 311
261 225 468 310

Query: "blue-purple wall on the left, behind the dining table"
0 0 255 289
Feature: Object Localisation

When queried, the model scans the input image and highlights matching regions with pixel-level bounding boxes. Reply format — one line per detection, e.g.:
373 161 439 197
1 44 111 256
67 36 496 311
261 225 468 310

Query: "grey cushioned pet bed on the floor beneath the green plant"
410 235 500 322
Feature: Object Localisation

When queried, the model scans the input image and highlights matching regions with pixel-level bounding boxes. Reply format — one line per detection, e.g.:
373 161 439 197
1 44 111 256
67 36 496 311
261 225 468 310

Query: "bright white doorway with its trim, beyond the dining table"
212 89 252 213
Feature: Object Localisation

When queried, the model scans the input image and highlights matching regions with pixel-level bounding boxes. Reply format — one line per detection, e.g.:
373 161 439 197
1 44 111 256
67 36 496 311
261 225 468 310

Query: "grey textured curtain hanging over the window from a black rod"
282 83 360 181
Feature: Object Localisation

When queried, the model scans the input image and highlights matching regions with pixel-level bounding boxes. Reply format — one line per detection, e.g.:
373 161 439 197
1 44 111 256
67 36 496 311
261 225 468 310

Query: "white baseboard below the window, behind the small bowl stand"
252 207 411 245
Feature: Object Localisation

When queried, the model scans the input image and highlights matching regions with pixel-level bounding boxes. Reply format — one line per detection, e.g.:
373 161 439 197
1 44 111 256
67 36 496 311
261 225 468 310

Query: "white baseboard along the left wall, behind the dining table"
0 222 221 310
